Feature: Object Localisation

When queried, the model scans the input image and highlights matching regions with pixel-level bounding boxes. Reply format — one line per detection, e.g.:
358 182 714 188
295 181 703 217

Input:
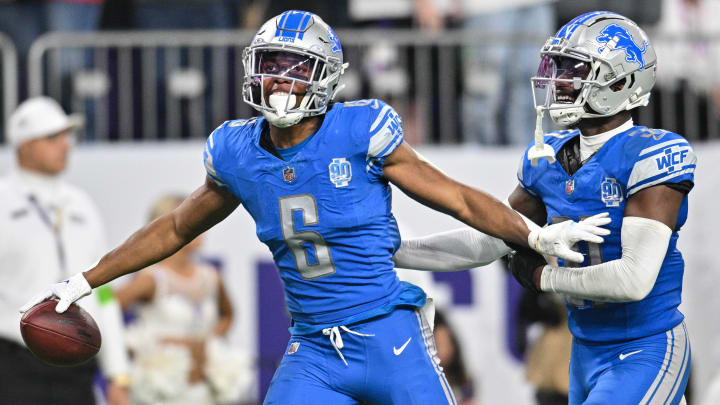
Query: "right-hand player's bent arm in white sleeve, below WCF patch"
511 185 684 302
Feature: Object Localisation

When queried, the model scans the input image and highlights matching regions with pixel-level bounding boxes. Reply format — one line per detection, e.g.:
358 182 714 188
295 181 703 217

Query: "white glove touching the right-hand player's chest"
528 212 611 263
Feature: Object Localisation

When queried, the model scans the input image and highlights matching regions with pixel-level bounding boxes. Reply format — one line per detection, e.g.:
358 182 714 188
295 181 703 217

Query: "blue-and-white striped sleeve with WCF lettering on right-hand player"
627 131 697 197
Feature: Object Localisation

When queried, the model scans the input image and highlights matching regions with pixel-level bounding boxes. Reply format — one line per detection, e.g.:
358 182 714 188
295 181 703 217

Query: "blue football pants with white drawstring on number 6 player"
264 300 455 405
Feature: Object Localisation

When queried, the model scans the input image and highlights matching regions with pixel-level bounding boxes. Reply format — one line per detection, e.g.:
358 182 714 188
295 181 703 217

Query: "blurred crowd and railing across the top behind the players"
0 0 720 145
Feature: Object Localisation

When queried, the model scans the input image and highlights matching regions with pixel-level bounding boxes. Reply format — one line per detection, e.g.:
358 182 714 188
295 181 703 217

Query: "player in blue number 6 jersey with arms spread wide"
23 11 609 405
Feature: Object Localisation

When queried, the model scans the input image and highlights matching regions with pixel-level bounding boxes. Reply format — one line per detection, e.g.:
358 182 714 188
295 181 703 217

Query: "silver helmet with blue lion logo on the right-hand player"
531 11 657 126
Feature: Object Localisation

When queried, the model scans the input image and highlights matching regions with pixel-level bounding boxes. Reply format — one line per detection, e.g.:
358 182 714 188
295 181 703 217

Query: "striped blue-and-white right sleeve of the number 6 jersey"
357 100 404 177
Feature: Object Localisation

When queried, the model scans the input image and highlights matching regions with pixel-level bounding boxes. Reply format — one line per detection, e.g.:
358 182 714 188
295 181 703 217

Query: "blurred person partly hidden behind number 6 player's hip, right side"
434 310 475 405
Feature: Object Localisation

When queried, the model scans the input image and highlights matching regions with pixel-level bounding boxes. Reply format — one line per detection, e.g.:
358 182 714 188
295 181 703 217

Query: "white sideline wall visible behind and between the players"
0 142 720 404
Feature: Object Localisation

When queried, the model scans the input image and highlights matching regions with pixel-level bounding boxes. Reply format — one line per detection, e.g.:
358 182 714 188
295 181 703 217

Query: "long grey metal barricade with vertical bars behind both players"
28 30 718 143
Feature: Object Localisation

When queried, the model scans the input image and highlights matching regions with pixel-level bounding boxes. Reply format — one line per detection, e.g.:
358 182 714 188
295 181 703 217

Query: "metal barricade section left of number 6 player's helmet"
28 31 252 140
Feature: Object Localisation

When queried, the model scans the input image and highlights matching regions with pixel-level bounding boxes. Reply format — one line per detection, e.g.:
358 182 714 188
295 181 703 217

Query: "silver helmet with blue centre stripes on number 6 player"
243 10 348 128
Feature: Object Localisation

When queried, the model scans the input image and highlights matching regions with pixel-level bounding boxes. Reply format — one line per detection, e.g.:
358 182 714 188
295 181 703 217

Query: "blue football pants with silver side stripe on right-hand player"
569 322 690 405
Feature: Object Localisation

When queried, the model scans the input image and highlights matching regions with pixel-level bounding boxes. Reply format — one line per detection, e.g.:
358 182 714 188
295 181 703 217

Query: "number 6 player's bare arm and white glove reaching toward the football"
20 178 240 312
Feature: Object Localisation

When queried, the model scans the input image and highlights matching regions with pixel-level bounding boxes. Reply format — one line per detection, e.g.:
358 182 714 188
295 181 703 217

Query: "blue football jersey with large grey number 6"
204 100 425 332
